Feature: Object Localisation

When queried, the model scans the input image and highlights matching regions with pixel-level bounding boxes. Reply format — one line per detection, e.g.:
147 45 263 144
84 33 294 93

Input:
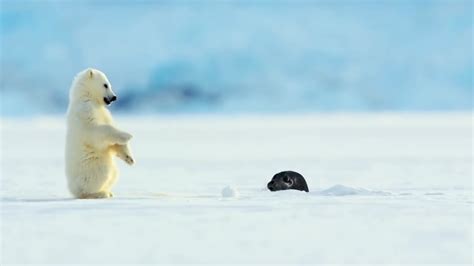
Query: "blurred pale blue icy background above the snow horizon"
0 0 473 116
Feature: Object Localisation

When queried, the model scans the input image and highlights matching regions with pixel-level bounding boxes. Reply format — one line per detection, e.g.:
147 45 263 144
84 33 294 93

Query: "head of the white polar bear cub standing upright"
71 68 117 105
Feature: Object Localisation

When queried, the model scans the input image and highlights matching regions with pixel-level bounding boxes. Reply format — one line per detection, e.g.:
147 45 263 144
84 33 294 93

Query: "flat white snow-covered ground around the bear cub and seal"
0 113 473 265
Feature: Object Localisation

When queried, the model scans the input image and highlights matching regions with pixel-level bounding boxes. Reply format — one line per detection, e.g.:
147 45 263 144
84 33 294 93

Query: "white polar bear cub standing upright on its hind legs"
66 68 134 198
